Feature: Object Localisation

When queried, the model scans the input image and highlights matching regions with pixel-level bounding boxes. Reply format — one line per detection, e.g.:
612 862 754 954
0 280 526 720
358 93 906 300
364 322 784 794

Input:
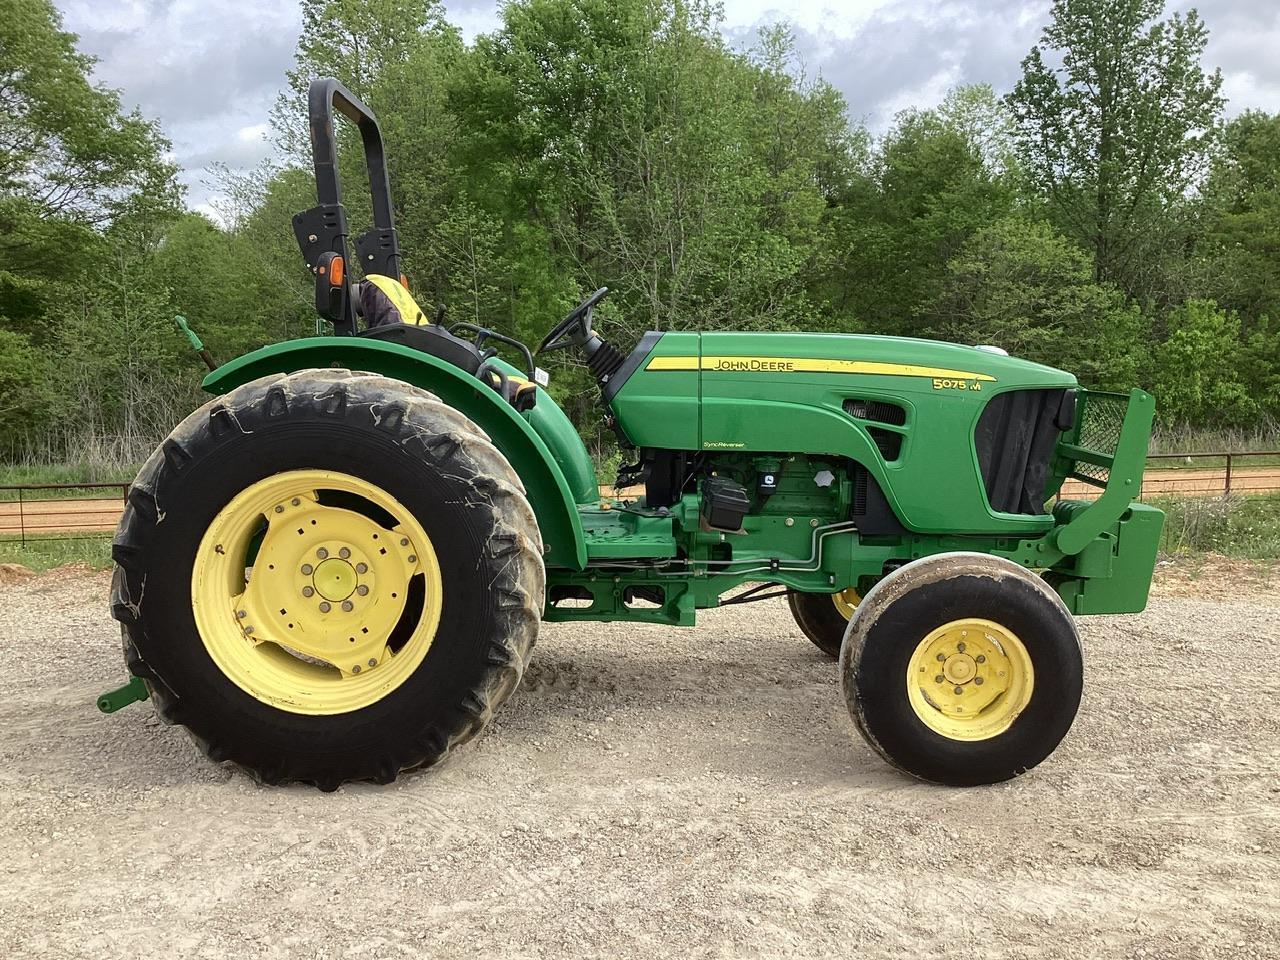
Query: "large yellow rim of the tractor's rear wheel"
191 470 443 714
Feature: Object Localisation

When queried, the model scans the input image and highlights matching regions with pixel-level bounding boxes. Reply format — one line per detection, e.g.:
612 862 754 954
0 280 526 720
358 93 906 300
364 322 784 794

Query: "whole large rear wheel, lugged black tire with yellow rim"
111 370 545 790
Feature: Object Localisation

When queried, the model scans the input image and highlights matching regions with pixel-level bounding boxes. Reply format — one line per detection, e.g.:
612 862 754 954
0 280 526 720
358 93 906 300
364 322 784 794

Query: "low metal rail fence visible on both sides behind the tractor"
0 451 1280 545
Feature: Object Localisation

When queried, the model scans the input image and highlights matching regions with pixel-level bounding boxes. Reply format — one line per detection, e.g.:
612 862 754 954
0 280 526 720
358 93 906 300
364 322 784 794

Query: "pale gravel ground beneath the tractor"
0 563 1280 960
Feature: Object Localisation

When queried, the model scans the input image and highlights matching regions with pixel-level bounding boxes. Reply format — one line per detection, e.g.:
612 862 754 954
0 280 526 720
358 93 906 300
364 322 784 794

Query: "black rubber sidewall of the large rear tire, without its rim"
112 371 540 785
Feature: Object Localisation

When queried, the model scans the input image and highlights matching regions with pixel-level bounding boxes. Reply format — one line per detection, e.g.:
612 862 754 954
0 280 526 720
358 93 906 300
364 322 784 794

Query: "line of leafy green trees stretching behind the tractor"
0 0 1280 462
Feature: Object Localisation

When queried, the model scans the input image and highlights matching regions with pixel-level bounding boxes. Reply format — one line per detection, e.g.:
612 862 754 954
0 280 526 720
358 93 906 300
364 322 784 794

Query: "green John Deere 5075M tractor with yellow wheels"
100 79 1164 790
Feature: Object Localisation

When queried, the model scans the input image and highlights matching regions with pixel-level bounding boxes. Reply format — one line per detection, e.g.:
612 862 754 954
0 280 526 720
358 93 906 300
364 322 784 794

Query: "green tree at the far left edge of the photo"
0 0 180 463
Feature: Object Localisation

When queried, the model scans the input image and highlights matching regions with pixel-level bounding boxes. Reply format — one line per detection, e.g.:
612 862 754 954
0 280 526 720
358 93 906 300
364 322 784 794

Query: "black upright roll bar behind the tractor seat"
293 77 401 335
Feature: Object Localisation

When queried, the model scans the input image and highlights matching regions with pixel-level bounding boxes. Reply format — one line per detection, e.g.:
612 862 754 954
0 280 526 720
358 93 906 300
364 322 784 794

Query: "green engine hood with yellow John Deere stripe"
616 333 1075 536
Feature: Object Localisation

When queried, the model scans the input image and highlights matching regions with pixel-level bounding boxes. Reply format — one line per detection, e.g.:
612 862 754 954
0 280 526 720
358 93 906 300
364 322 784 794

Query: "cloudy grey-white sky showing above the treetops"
55 0 1280 212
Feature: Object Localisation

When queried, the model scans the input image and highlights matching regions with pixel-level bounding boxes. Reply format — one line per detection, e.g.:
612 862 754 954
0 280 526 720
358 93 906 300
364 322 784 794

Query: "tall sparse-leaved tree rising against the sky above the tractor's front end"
1009 0 1224 300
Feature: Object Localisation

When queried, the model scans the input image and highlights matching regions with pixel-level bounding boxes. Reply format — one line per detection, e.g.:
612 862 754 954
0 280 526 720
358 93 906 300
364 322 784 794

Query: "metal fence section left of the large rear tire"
0 483 129 545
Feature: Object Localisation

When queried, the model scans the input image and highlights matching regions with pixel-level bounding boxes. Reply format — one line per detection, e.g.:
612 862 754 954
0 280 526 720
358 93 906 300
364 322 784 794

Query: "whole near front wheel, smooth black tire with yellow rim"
840 553 1083 786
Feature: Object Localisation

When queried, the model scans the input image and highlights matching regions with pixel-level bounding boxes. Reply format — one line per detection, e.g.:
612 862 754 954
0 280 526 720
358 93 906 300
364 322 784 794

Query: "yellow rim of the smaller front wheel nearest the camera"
906 618 1036 740
